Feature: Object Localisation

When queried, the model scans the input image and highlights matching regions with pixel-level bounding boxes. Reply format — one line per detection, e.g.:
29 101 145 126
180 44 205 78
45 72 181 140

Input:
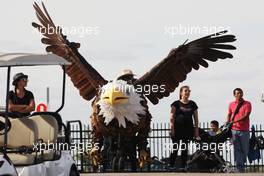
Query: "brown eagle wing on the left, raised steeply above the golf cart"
32 3 107 100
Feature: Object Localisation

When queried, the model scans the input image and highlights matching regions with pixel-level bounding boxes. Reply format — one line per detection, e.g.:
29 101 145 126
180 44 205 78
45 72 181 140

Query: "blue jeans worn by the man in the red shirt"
232 130 249 172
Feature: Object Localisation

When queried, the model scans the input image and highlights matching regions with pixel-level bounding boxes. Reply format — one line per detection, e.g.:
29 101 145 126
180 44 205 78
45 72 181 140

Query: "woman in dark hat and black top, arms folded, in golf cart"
9 73 35 117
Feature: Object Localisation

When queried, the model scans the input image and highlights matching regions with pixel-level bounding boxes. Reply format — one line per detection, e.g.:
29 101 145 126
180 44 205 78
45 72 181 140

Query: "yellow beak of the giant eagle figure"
103 88 128 106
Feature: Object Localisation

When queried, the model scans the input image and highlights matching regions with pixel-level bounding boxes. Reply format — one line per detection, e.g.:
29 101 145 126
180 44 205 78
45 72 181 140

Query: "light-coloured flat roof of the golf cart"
0 52 71 67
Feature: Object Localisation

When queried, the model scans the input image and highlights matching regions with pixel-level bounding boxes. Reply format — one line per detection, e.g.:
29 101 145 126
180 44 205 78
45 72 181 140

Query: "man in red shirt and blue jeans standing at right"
227 88 252 172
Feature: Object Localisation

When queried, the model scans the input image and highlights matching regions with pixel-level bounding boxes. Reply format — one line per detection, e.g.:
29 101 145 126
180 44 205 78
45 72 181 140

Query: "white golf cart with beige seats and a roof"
0 53 79 176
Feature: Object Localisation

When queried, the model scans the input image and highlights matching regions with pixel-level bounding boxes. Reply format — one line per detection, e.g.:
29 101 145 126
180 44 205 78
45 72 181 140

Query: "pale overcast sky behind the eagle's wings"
0 0 264 124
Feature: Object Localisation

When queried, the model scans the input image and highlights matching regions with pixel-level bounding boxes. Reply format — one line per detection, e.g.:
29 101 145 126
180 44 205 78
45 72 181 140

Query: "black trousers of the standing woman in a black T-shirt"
170 138 189 168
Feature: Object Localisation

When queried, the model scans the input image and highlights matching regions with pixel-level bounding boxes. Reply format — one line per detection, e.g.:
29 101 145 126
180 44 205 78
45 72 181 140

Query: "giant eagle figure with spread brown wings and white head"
32 3 236 170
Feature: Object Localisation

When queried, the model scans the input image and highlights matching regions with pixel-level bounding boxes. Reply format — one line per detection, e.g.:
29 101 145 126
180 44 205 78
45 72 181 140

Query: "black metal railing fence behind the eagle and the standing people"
68 123 264 172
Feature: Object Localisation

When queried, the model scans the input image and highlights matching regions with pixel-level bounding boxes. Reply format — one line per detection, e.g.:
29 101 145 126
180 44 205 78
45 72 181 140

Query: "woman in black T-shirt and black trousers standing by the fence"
170 86 200 169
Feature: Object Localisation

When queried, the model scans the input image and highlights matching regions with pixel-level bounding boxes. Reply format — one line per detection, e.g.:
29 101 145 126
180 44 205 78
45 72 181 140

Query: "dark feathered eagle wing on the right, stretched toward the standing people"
134 31 236 104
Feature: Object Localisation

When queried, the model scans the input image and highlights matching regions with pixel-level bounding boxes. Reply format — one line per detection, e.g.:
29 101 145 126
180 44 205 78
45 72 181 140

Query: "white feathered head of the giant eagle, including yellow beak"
97 80 146 128
